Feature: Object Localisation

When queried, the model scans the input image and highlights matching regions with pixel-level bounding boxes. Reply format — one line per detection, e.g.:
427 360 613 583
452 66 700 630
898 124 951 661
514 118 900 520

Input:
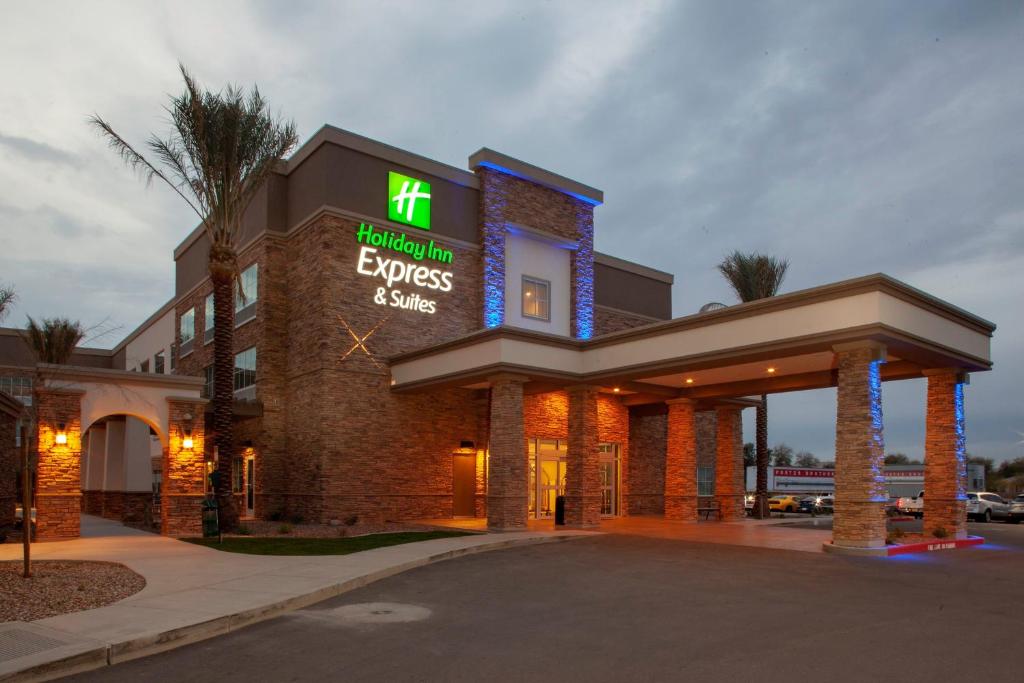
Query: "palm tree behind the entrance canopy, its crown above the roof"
718 251 790 519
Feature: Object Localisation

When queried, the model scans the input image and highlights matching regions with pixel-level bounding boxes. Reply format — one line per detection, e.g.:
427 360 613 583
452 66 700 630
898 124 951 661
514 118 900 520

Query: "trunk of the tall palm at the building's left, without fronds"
210 259 239 530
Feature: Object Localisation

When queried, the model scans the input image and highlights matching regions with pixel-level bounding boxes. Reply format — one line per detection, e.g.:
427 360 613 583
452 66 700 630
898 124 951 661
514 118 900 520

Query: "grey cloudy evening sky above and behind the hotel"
0 0 1024 460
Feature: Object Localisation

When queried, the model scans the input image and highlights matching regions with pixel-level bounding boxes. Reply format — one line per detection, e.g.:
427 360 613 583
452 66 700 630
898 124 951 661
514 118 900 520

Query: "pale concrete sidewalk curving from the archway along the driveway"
0 516 591 680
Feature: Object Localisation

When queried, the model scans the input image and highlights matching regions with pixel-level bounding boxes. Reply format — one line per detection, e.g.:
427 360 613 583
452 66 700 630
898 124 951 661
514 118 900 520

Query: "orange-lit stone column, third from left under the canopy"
665 398 697 521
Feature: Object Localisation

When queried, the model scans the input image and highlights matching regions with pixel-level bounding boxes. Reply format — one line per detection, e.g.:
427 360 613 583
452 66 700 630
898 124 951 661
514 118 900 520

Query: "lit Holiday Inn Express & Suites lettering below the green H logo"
355 223 455 314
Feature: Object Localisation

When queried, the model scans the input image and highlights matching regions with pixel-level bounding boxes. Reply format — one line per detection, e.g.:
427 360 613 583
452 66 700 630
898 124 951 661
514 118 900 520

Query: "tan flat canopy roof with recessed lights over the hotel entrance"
389 274 995 399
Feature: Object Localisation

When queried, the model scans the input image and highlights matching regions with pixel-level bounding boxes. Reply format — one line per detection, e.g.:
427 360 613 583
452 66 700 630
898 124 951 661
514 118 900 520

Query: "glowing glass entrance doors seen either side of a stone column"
527 439 622 519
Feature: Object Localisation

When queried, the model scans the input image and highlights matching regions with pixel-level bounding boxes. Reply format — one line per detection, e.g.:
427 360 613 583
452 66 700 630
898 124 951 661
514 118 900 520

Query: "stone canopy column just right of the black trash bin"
565 385 601 528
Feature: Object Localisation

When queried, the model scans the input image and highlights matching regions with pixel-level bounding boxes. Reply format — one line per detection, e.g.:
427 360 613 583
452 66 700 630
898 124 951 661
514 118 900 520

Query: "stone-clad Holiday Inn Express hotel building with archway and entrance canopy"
0 127 994 557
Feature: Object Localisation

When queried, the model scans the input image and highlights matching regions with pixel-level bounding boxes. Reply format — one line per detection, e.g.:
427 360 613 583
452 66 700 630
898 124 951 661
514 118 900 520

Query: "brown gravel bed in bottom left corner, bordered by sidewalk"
0 560 145 622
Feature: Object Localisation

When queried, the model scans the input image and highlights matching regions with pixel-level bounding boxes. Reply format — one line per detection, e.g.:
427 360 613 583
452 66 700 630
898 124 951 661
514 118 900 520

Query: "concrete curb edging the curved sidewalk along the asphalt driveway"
0 533 597 681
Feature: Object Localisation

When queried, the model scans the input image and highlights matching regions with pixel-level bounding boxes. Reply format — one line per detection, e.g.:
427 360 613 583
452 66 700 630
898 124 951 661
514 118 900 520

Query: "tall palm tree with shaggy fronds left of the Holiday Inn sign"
91 65 298 530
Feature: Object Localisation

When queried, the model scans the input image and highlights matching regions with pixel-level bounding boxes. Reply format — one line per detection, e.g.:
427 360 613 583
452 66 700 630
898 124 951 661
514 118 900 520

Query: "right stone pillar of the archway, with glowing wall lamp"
160 398 206 536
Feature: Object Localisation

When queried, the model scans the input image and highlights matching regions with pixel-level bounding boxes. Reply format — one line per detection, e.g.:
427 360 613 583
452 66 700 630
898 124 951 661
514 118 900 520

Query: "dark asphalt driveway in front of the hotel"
68 524 1024 683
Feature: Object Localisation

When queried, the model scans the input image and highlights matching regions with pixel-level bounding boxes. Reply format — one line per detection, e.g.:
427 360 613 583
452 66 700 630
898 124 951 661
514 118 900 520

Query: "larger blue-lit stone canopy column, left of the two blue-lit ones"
833 342 888 548
